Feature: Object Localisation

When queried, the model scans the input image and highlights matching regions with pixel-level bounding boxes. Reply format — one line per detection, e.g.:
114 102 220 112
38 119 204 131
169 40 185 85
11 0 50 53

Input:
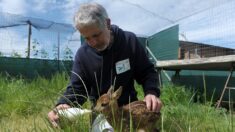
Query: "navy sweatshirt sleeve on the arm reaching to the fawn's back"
132 35 160 97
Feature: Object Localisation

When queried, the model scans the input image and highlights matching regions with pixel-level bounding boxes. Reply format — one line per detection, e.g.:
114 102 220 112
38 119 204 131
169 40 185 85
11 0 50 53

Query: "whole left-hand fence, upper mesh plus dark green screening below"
0 12 80 78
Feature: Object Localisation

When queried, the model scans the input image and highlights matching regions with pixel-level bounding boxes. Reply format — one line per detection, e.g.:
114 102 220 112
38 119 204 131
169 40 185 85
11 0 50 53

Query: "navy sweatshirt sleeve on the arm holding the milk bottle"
57 50 88 106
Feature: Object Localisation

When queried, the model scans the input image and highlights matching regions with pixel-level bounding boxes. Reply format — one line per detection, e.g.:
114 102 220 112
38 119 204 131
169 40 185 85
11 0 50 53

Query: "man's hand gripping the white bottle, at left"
48 104 71 127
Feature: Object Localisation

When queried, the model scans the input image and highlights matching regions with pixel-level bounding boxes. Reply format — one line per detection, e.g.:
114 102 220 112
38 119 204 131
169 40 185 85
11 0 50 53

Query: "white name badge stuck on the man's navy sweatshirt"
116 59 131 74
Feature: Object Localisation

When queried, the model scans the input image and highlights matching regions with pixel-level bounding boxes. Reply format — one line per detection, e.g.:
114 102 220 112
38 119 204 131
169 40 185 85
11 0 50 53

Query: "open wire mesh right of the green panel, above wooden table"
179 1 235 59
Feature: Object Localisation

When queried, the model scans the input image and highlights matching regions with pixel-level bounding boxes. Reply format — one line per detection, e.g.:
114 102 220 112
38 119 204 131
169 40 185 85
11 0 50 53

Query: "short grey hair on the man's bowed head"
74 3 108 28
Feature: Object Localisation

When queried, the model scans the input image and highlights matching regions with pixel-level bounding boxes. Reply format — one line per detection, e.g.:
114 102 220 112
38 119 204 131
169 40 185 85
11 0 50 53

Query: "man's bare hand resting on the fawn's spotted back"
144 94 162 112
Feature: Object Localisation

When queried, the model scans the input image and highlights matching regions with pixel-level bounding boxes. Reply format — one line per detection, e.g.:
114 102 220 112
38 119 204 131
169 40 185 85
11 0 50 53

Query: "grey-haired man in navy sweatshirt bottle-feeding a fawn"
48 3 162 126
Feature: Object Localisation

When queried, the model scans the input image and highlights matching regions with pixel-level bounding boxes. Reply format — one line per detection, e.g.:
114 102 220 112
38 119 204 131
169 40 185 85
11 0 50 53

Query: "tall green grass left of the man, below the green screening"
0 73 68 131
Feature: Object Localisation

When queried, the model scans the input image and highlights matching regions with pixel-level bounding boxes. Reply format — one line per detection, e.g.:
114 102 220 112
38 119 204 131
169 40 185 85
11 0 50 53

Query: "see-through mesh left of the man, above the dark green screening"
0 12 80 60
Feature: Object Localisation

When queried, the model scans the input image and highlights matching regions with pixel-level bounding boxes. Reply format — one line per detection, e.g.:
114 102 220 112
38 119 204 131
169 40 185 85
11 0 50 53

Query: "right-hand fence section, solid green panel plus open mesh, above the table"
144 1 235 60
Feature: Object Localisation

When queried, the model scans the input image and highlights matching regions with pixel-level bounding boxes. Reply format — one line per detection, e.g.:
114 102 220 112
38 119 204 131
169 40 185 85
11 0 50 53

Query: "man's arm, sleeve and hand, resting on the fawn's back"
131 33 162 112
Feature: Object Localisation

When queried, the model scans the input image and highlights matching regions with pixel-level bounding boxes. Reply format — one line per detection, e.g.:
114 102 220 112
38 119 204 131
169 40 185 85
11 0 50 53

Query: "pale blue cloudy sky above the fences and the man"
0 0 235 58
